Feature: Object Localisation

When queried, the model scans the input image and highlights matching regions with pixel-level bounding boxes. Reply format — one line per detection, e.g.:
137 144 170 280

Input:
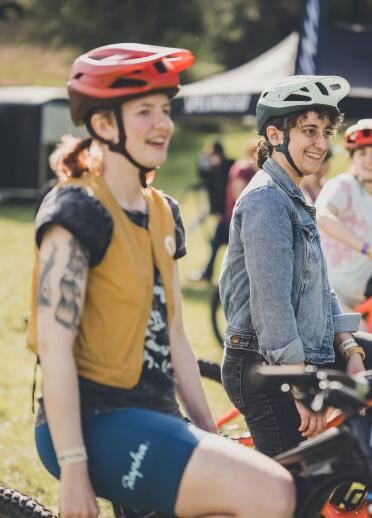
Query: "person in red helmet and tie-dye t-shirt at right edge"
316 119 372 329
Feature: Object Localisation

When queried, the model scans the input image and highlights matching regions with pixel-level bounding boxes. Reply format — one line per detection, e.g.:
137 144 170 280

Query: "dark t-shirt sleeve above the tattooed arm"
35 185 113 267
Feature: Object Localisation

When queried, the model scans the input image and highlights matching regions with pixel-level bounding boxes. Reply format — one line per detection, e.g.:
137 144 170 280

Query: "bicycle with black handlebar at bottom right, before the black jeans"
251 366 372 518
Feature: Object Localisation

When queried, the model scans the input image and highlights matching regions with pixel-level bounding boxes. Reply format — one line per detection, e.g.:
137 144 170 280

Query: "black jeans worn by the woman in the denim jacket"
222 332 372 457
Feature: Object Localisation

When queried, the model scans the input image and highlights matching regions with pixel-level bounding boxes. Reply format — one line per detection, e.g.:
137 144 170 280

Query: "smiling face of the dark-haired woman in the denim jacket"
288 111 332 175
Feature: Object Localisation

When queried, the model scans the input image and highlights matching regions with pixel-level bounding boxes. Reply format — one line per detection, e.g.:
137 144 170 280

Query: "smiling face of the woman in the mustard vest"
122 93 174 168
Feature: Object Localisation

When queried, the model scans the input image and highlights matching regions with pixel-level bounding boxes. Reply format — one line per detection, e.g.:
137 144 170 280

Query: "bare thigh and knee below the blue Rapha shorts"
176 436 295 518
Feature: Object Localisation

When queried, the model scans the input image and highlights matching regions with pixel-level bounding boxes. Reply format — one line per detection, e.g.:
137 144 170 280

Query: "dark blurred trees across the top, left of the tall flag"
26 0 326 73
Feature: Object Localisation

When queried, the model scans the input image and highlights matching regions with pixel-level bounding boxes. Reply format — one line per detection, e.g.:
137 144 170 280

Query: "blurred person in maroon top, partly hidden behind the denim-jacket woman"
190 144 257 281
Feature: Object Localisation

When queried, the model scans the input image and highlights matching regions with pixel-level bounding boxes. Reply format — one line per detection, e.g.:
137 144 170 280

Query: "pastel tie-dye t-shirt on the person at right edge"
316 173 372 307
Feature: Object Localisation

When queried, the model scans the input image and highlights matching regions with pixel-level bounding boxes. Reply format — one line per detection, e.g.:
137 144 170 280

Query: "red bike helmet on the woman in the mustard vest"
68 43 194 125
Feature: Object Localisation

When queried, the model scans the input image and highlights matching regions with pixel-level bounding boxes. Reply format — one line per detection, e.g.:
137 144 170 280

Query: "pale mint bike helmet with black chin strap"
256 76 350 176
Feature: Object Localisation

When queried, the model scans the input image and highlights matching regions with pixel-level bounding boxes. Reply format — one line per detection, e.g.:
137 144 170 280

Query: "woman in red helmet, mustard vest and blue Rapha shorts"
28 44 294 518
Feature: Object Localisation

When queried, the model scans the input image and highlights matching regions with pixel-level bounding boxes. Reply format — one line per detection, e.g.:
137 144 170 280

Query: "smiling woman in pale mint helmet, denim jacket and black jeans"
220 76 372 456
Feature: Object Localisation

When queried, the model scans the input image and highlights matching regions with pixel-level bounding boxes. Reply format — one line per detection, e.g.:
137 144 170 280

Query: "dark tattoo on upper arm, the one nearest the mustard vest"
55 238 89 329
